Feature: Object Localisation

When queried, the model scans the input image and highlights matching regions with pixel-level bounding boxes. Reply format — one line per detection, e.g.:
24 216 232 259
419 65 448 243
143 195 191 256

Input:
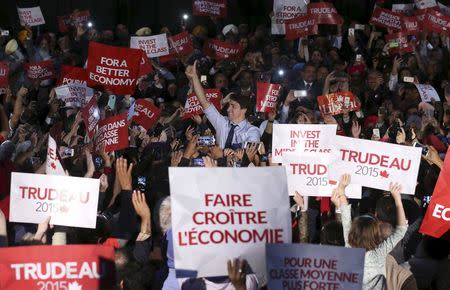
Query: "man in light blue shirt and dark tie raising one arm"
186 61 261 149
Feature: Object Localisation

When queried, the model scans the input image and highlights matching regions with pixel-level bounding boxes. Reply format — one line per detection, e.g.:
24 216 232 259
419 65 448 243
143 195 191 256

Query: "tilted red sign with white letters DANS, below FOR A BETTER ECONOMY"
95 112 128 152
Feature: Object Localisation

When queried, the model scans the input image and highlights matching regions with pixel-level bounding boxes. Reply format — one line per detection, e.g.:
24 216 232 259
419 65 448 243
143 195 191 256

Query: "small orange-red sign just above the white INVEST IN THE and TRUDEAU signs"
317 92 360 115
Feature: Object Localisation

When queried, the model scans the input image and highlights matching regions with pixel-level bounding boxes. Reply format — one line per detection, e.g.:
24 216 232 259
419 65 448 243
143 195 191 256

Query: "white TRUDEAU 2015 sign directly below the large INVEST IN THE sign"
283 153 362 199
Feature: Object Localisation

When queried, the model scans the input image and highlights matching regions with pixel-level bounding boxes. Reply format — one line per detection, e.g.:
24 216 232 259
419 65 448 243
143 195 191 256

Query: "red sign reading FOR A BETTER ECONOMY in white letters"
86 41 142 95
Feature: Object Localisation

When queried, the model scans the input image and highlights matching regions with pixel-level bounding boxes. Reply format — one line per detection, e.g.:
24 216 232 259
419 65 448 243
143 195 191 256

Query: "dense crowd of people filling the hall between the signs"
0 2 450 290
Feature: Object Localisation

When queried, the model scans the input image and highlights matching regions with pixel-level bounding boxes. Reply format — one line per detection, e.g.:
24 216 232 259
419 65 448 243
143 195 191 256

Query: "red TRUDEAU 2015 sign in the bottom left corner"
0 245 116 290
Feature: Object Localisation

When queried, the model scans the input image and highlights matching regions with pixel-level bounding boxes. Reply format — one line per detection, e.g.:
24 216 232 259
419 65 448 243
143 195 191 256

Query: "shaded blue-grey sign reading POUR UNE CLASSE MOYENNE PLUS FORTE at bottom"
266 244 365 290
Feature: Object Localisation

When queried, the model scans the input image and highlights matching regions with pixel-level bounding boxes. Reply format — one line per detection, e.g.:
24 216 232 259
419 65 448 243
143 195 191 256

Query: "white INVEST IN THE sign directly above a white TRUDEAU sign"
272 124 337 163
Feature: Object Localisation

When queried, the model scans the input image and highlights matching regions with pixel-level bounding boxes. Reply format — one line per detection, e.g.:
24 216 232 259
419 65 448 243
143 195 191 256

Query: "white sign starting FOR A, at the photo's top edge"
271 0 309 34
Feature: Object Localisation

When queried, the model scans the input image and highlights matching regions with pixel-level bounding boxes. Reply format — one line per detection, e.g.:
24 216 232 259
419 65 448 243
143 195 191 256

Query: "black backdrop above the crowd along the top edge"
0 0 450 34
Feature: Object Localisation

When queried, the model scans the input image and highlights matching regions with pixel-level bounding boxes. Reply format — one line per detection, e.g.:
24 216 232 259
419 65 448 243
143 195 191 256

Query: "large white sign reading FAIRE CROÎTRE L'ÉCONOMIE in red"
169 166 292 281
